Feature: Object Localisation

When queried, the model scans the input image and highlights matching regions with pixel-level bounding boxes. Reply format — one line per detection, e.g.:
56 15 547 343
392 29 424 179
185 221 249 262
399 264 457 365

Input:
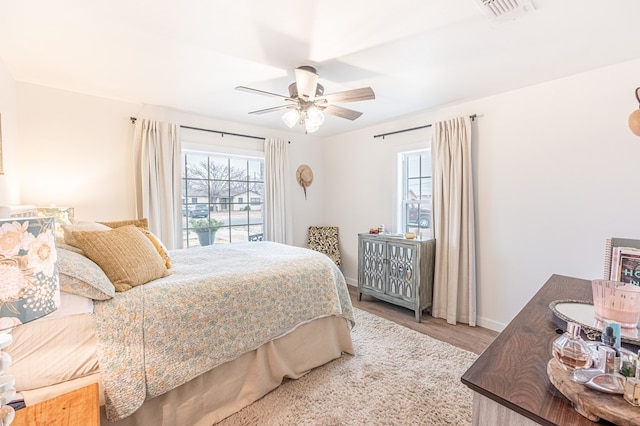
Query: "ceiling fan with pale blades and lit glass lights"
236 65 376 133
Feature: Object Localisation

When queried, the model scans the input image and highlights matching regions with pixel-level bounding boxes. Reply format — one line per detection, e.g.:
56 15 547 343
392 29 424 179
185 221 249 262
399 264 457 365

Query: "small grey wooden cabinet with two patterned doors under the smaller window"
358 234 436 322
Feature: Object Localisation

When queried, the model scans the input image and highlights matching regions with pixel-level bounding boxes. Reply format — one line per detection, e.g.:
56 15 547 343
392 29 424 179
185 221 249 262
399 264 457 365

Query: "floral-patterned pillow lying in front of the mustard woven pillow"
57 247 116 300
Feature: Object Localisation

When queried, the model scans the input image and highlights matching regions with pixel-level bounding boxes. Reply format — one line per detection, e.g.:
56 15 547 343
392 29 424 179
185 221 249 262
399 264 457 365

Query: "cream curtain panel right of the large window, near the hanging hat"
264 138 293 244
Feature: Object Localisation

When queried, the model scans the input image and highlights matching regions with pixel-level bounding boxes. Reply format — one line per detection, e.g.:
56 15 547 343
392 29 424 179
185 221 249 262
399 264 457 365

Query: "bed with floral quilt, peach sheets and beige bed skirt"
8 220 354 425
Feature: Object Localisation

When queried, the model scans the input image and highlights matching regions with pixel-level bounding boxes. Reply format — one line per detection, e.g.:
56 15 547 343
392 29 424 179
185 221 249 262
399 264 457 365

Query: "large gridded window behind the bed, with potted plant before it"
182 151 264 247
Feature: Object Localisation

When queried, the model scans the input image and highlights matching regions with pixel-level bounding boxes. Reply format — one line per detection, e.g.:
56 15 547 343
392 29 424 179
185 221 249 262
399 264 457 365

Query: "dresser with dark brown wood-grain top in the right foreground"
462 275 632 426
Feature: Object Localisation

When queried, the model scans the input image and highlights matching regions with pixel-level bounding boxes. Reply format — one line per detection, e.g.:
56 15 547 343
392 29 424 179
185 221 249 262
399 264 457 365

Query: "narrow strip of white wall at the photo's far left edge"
0 60 20 206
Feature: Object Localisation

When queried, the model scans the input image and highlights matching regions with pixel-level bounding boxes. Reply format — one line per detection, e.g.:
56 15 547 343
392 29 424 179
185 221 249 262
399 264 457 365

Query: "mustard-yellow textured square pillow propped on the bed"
73 225 169 291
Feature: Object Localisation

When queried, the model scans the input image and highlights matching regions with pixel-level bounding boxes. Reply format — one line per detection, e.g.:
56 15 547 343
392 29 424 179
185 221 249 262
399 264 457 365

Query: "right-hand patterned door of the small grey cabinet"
386 242 420 302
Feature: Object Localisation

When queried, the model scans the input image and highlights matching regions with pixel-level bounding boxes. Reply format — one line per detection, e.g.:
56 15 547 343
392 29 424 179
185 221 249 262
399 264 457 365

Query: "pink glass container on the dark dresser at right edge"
591 280 640 328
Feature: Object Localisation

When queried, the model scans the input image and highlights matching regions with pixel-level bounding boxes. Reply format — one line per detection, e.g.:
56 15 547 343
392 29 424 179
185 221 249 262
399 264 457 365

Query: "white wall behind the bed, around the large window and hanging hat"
15 83 324 246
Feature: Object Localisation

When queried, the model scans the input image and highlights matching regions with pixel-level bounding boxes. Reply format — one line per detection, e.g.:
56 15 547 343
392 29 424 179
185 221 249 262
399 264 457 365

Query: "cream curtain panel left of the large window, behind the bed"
133 119 182 249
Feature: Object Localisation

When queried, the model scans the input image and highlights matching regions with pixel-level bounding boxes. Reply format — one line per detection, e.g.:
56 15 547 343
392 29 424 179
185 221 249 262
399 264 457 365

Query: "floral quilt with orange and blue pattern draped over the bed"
95 242 353 420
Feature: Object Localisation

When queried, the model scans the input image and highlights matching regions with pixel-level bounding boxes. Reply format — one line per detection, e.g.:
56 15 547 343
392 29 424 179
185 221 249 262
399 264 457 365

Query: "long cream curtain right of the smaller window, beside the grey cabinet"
431 117 476 326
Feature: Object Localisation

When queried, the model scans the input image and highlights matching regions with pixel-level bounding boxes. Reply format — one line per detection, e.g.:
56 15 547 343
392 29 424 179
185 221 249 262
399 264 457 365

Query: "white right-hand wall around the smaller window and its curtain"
324 60 640 330
